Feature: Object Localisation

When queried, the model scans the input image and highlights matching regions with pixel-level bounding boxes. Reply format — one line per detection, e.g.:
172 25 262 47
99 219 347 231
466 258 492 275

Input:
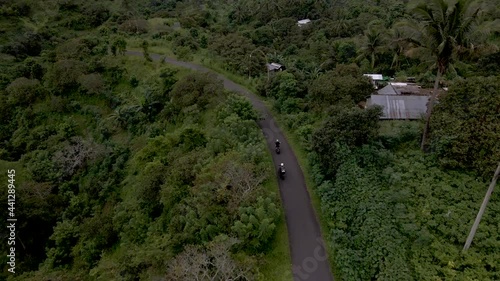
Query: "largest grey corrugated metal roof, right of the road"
367 95 429 119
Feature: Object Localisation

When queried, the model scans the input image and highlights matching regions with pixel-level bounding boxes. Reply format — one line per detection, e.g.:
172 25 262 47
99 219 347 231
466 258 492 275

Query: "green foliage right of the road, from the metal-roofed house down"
281 72 500 280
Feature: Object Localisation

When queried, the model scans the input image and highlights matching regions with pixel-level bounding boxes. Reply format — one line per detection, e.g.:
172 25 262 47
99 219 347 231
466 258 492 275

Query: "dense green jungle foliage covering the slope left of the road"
0 1 282 281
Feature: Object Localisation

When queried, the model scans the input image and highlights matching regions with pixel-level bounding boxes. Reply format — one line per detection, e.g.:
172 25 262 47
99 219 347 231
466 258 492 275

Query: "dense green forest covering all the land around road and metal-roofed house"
0 0 500 280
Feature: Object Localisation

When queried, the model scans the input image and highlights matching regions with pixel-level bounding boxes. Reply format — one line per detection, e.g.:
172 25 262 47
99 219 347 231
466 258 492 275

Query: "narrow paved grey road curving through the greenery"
127 51 333 281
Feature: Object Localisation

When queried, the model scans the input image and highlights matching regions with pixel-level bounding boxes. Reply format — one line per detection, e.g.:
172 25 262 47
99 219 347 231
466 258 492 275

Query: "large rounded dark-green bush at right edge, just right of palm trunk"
431 76 500 178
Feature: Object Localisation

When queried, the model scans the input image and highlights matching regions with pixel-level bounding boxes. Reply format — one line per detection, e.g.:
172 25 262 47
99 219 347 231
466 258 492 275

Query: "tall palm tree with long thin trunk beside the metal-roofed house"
398 0 496 150
